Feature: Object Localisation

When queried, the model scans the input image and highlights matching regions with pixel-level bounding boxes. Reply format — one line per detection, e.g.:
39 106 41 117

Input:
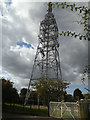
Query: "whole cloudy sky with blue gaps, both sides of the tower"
0 0 88 93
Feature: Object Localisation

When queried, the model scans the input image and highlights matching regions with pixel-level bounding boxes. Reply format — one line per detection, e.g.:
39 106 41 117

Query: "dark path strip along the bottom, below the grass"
2 114 61 120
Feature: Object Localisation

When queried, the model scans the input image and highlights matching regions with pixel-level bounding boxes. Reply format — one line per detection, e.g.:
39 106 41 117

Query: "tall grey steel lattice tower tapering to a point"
25 3 62 104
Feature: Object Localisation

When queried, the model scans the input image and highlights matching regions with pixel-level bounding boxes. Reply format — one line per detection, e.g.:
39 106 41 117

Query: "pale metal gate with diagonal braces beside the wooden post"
49 102 79 120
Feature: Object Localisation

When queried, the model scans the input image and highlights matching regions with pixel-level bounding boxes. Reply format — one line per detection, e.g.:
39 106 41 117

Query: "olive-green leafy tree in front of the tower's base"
32 77 70 105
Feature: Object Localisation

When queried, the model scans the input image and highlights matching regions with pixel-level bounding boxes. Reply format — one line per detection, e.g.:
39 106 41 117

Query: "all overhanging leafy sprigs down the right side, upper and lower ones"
48 2 90 95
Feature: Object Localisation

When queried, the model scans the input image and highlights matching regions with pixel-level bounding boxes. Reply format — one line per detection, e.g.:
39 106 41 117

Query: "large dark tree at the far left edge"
0 79 19 103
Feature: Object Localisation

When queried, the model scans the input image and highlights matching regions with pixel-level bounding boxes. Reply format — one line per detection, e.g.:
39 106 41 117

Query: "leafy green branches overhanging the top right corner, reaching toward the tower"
49 2 90 40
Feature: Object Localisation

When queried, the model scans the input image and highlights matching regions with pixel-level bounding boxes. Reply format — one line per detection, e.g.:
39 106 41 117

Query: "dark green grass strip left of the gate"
2 103 48 116
